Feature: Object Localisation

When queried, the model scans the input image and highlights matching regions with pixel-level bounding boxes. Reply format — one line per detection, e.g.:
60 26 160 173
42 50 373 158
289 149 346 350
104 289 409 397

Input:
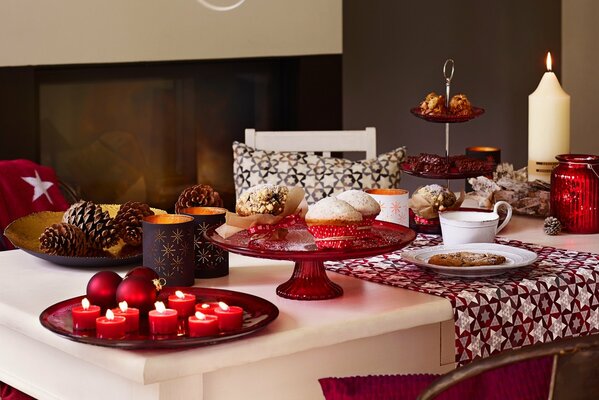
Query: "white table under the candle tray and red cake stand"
0 217 599 400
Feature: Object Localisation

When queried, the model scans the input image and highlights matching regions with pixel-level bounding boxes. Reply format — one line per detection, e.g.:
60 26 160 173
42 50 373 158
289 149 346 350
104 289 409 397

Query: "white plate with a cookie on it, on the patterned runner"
401 243 537 278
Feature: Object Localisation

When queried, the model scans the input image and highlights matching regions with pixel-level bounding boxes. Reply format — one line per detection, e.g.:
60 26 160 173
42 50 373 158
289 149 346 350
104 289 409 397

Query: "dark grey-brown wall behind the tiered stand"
343 0 561 190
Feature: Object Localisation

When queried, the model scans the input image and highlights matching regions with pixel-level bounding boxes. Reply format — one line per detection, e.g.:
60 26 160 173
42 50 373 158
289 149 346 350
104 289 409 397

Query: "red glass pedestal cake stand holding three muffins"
206 221 416 300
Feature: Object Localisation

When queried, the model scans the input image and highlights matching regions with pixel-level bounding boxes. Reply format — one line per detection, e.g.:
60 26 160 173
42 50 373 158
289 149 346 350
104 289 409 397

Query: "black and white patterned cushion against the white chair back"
233 142 406 204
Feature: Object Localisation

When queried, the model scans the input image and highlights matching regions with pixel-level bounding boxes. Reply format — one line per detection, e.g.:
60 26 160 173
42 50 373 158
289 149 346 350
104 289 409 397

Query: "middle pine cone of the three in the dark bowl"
62 200 119 249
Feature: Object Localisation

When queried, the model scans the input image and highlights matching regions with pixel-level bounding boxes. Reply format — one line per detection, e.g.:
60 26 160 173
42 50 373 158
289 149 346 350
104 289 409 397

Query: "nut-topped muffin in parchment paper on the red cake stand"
235 183 289 217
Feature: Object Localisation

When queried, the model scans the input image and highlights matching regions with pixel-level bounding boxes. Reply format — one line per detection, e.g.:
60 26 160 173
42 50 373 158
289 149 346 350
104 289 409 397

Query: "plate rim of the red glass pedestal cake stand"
205 221 416 261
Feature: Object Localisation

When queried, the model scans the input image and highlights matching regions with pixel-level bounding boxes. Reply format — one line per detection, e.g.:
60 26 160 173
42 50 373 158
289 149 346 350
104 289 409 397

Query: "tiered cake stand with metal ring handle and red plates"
401 59 493 234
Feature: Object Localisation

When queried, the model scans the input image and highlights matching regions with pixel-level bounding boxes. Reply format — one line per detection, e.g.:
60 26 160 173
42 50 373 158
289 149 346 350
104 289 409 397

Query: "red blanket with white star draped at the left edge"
0 160 69 249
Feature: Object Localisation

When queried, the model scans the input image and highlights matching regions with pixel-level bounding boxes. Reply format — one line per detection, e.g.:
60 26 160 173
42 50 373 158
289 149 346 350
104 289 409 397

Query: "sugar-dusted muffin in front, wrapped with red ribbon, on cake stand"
306 197 362 248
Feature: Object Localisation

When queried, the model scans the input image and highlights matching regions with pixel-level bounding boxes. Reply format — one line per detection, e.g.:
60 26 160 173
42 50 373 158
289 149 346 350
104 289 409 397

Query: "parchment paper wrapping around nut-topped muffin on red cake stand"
216 187 308 239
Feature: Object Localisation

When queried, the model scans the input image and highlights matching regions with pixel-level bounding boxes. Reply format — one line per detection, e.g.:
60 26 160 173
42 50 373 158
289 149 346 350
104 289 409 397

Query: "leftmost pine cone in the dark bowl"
40 222 87 257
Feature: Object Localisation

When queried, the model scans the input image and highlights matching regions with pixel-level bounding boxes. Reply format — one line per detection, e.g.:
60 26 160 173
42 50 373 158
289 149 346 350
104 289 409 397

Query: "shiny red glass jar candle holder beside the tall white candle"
550 154 599 233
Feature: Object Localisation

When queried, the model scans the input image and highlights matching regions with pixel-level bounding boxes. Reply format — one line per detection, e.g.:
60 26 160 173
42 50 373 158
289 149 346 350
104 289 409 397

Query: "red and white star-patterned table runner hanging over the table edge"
325 235 599 365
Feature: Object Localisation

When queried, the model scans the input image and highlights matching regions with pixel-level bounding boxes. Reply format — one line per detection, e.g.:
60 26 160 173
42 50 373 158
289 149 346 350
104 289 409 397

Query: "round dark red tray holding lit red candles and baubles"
39 287 279 350
